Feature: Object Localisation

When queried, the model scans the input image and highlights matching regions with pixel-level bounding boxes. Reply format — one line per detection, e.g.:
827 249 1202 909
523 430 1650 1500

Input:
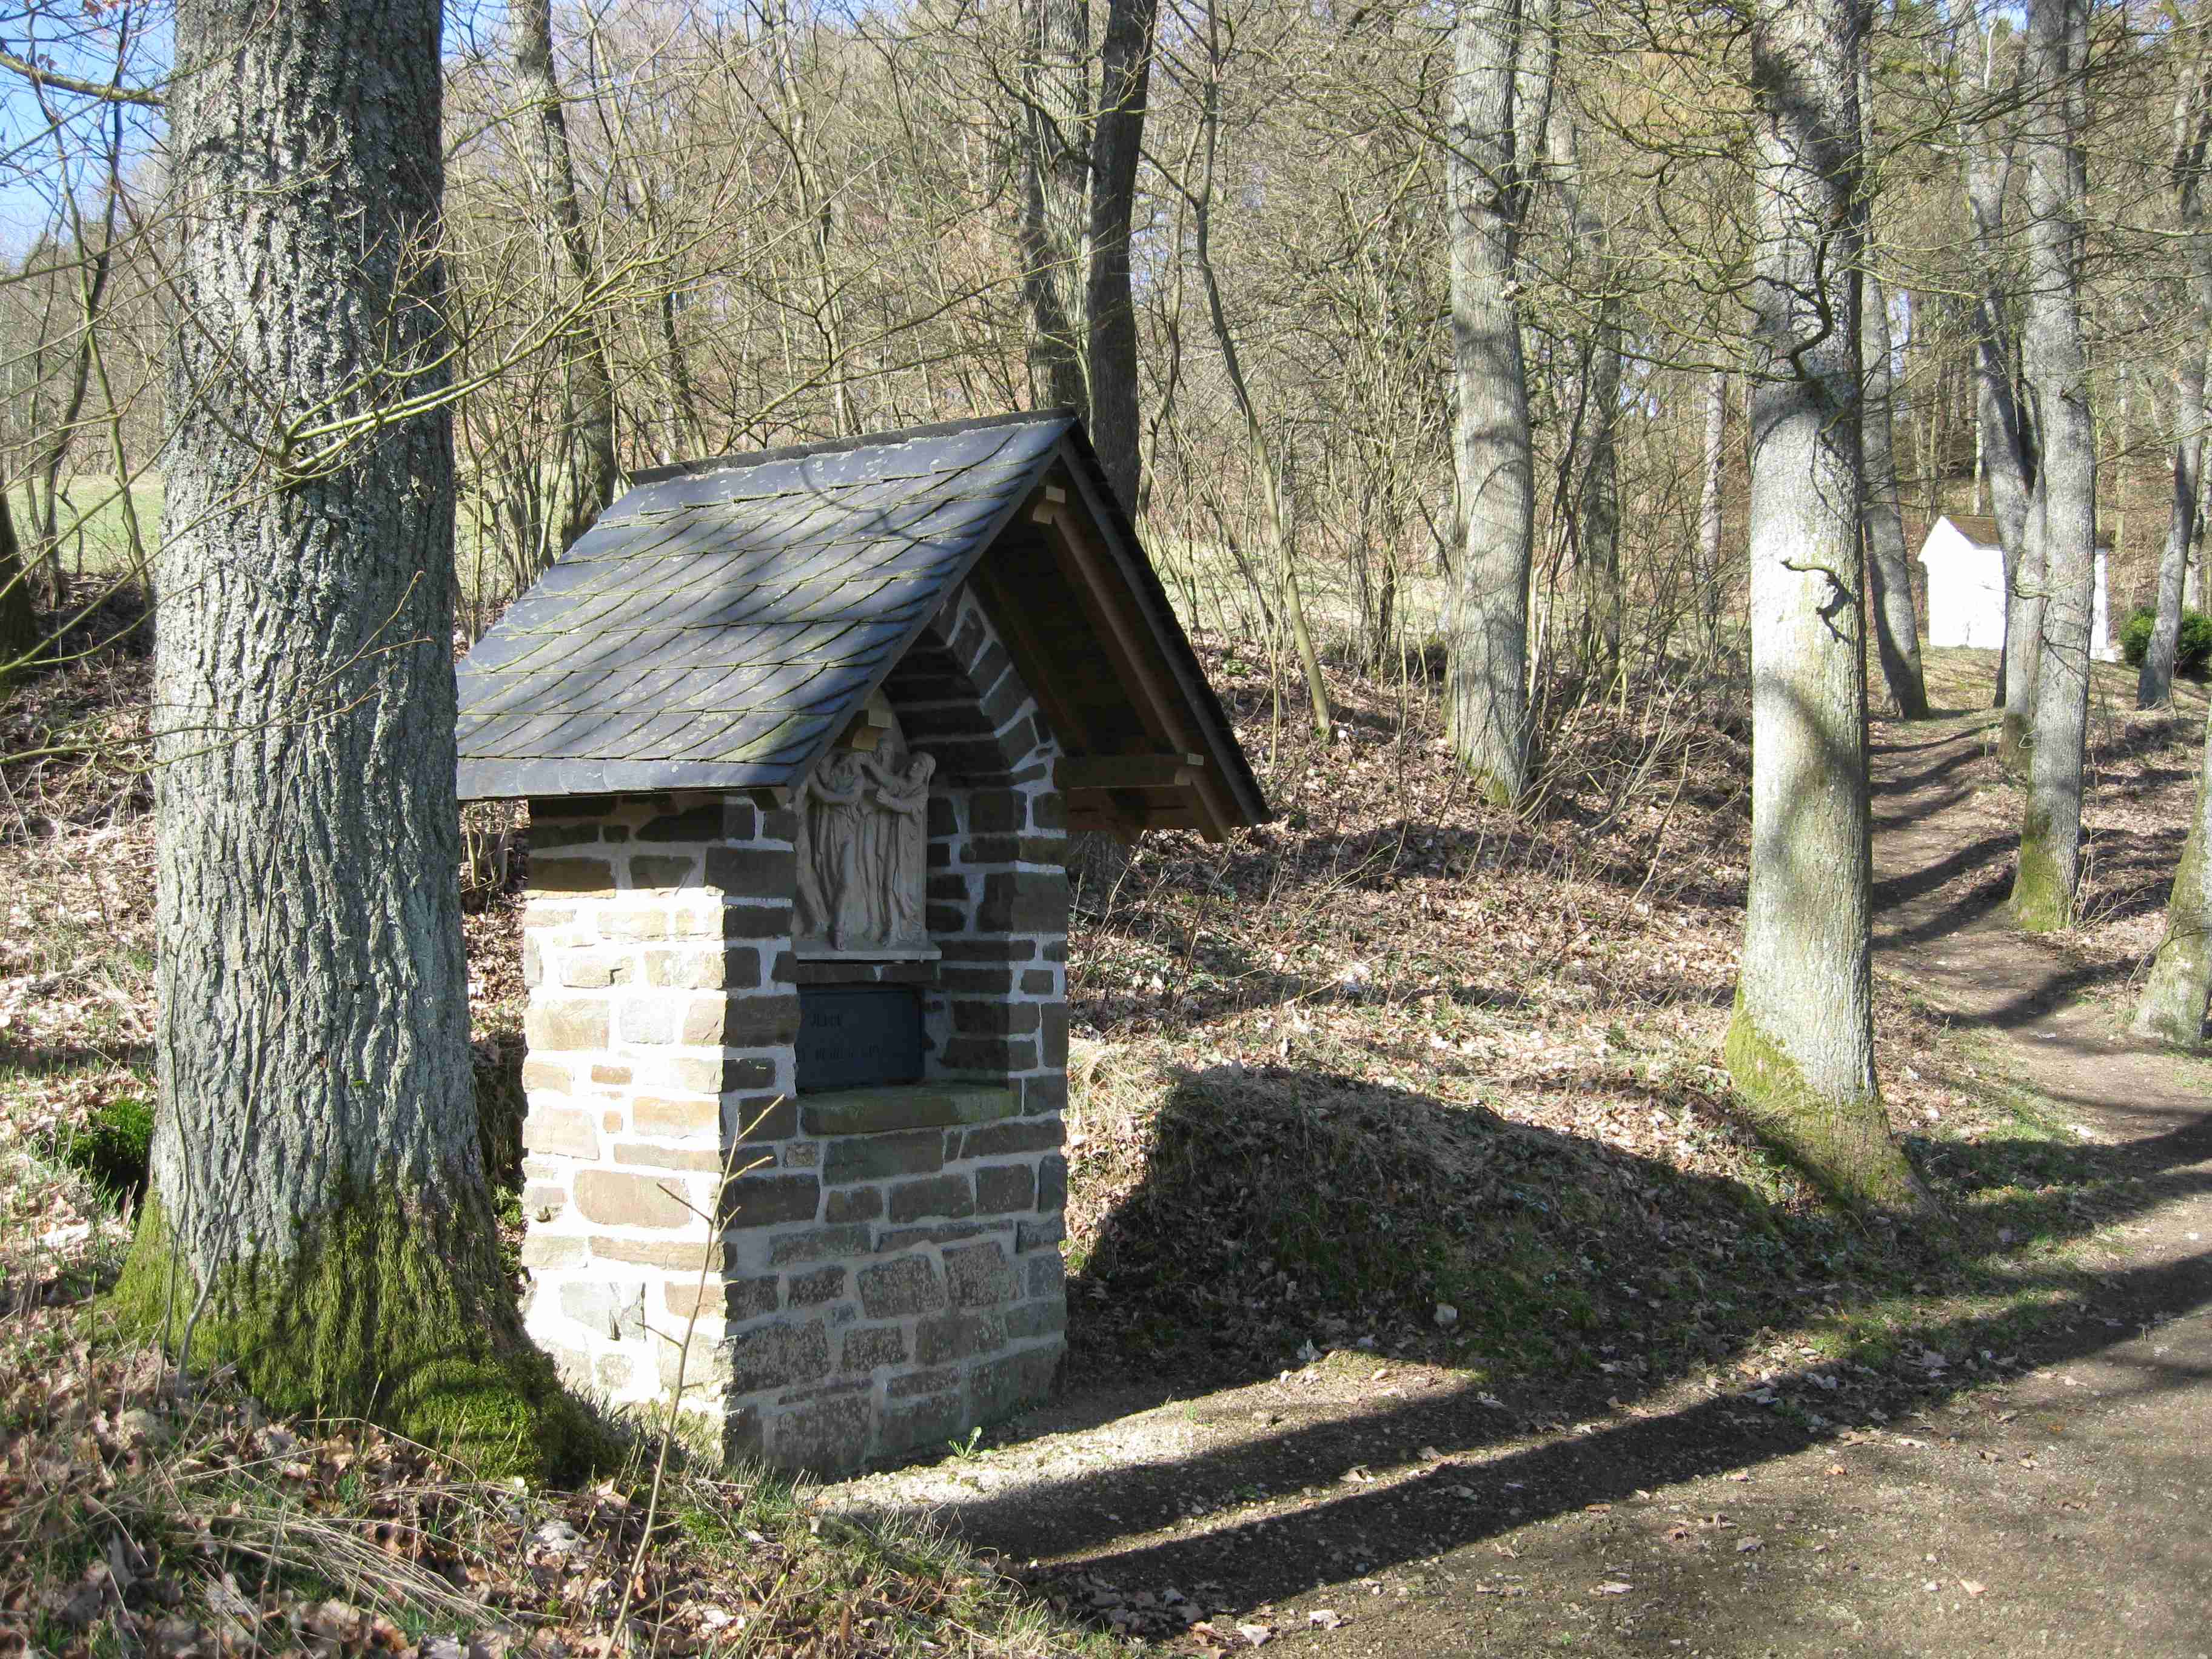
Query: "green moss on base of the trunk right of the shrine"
1723 1000 1936 1219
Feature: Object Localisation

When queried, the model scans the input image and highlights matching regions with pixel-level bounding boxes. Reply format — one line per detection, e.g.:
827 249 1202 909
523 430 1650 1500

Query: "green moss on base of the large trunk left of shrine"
110 1195 611 1478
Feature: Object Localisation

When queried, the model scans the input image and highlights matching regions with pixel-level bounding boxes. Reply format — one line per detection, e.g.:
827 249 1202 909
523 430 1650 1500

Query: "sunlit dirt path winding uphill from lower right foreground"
830 717 2212 1659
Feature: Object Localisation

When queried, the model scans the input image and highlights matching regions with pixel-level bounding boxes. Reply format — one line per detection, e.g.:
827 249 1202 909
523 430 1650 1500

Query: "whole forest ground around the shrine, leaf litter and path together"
0 635 2212 1659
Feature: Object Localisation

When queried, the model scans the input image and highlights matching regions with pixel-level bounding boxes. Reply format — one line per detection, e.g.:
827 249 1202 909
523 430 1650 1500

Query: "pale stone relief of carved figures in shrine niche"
792 734 938 956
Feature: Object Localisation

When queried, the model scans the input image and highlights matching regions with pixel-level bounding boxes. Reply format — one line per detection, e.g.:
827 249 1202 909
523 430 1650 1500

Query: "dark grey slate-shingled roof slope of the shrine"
460 409 1078 801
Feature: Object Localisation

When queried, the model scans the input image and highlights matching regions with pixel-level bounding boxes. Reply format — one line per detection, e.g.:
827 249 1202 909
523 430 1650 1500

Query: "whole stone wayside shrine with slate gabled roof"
460 412 1267 1471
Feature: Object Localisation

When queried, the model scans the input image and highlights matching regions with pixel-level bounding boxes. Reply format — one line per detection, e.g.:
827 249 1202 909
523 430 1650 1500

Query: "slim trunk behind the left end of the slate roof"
515 0 622 553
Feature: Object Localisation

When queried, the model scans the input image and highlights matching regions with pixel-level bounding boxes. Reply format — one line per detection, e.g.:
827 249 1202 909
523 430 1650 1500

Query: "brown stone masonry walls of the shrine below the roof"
525 593 1068 1471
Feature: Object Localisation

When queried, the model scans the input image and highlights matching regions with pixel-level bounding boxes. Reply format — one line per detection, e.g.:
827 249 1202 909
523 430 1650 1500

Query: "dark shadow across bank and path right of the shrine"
889 1073 2212 1637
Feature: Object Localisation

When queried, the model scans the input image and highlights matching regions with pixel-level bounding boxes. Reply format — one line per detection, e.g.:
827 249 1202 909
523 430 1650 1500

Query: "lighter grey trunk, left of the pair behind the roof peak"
1022 0 1088 418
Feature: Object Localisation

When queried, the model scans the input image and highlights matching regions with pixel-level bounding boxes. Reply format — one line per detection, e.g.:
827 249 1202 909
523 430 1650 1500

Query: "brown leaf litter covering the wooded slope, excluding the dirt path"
0 615 2194 1659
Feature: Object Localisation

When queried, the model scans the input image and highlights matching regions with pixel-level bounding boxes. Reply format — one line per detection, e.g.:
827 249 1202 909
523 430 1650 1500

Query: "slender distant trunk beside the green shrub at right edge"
2141 38 2212 708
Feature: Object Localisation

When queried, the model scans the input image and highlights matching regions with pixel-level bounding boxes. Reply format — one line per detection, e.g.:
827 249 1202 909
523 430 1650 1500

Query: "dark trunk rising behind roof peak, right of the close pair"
1088 0 1159 518
